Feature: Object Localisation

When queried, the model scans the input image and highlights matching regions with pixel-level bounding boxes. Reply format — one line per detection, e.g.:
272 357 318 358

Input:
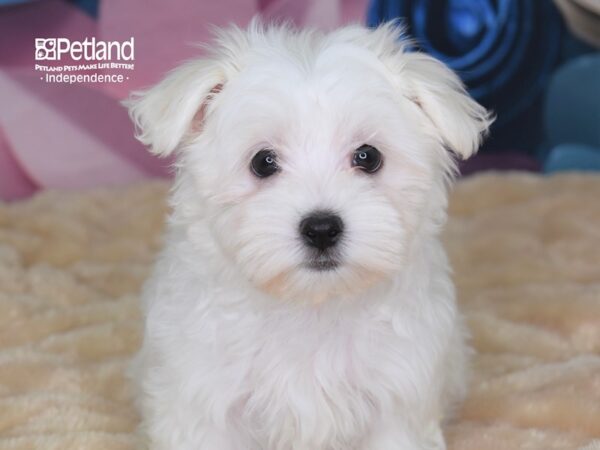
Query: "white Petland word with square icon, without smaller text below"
35 37 135 61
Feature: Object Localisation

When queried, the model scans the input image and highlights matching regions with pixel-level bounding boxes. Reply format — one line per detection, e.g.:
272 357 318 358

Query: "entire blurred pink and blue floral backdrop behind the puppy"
0 0 600 201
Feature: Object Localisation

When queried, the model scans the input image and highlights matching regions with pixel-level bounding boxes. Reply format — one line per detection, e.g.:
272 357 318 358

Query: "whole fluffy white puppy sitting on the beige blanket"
128 21 490 450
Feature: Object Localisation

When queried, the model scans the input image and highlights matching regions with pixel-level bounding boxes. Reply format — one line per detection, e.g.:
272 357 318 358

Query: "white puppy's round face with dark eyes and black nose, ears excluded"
202 47 435 299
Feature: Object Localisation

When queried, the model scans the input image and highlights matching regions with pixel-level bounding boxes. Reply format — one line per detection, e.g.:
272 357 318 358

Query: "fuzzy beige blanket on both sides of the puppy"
0 174 600 450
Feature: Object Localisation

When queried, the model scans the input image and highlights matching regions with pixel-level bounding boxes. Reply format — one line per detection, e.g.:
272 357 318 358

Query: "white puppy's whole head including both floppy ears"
129 22 490 301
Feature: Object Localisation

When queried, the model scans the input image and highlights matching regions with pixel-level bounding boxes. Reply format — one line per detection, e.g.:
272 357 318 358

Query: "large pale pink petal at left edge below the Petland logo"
0 71 166 189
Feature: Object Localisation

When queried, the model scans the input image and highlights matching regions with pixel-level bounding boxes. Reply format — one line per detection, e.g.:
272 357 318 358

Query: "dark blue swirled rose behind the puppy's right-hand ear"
367 0 563 130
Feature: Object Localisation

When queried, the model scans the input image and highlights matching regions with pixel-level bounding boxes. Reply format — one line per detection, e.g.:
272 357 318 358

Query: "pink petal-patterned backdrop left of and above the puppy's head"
0 0 367 200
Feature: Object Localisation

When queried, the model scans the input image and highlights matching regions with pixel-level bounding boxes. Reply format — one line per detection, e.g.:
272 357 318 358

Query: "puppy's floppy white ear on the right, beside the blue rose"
402 52 494 159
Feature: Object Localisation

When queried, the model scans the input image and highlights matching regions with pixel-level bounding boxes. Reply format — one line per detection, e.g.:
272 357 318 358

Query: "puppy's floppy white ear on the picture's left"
123 60 225 156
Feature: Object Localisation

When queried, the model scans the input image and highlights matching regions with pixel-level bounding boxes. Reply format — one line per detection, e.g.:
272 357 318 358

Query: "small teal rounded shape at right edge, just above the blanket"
544 144 600 173
